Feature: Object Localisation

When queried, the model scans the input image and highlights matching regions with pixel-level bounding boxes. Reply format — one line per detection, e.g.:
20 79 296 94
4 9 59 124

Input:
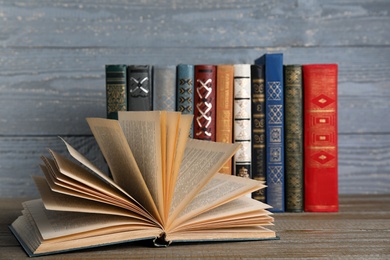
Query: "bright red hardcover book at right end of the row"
302 64 338 212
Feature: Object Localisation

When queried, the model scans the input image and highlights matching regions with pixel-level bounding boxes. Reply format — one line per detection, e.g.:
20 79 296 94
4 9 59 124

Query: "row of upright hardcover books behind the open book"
106 53 338 212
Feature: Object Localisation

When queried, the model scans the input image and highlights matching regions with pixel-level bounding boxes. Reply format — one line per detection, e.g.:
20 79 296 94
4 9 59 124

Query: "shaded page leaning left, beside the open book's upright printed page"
87 118 161 221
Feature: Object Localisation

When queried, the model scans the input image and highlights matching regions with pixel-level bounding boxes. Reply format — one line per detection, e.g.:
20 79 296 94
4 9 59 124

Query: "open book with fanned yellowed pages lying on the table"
10 111 276 256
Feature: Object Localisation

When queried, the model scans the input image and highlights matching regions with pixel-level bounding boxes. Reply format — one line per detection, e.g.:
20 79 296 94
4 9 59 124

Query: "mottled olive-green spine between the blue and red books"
284 65 303 212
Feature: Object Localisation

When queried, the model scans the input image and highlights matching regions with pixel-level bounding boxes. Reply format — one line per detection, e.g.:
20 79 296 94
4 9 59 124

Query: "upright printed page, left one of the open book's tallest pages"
118 111 166 216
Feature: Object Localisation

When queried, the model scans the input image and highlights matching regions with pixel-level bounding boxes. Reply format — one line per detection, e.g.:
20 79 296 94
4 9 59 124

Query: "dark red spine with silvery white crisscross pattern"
194 65 217 141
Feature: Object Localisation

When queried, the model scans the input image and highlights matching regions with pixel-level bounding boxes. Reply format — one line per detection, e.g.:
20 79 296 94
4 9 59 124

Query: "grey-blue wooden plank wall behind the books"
0 0 390 197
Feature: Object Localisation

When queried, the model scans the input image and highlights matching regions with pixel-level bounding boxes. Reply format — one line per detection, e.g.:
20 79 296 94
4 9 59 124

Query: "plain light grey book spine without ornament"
153 65 176 111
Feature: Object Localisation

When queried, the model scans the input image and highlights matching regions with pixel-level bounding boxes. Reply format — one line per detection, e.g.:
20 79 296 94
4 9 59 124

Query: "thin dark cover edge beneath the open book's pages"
8 225 280 257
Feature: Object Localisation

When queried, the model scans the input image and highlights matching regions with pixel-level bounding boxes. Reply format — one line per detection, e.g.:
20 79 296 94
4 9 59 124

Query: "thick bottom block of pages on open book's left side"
12 200 161 256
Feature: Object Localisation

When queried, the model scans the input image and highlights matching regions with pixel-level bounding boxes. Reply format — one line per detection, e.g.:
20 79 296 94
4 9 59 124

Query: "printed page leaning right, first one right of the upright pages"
169 139 240 223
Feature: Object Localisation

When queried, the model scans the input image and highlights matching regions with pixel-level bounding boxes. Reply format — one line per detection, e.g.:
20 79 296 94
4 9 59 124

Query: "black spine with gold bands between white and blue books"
251 65 266 202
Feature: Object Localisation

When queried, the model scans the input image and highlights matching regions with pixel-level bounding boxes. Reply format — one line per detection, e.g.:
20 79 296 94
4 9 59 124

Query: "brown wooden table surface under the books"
0 194 390 259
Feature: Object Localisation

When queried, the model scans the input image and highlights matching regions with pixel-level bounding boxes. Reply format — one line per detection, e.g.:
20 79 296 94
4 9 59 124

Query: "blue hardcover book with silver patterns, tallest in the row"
255 53 285 212
